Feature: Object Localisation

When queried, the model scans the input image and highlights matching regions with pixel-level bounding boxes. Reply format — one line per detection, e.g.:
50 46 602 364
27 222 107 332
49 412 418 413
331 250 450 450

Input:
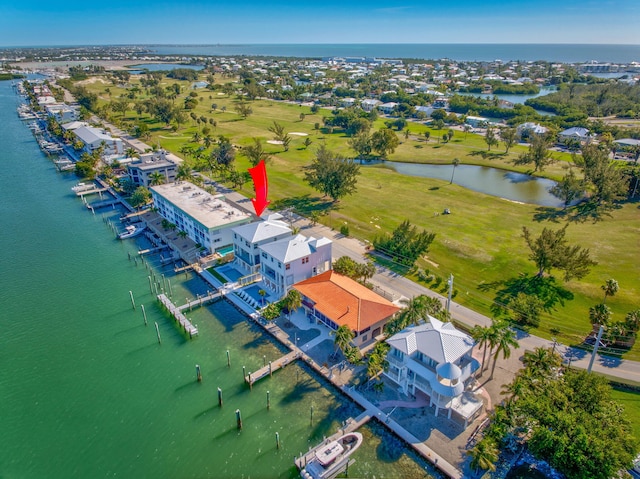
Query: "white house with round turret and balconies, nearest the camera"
384 316 483 427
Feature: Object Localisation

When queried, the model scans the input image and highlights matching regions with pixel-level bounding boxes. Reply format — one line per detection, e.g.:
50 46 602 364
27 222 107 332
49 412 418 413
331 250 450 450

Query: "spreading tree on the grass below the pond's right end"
522 225 598 281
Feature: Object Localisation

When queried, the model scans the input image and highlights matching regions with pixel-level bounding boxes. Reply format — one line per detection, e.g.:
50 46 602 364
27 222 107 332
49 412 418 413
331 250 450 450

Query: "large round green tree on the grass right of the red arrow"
304 145 360 201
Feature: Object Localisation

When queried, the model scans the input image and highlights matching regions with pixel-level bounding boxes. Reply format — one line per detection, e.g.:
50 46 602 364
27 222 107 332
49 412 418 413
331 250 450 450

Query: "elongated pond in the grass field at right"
385 161 563 207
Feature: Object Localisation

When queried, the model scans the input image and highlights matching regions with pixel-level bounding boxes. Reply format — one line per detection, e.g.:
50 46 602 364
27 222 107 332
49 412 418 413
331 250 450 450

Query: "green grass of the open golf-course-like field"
80 74 640 359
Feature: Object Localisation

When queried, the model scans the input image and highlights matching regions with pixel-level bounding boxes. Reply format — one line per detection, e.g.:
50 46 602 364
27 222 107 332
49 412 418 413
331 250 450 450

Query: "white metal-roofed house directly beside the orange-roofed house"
259 234 331 296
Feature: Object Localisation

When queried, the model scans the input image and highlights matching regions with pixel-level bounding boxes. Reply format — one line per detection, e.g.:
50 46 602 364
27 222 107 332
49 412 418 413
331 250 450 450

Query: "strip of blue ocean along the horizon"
149 43 640 63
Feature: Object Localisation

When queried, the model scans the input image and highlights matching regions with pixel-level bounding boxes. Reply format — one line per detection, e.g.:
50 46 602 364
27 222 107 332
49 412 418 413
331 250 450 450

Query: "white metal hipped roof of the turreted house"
387 316 475 364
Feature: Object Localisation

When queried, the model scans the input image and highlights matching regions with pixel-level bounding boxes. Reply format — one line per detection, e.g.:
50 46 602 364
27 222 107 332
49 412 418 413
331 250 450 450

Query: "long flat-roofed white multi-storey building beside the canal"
150 181 251 254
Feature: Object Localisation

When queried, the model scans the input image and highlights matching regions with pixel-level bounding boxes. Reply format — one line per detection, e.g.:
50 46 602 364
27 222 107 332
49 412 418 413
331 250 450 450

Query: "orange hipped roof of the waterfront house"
293 270 400 332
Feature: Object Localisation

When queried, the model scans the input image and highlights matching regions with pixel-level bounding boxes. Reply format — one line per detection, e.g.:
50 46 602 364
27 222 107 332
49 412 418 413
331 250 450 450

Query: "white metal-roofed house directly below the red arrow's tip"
233 213 292 272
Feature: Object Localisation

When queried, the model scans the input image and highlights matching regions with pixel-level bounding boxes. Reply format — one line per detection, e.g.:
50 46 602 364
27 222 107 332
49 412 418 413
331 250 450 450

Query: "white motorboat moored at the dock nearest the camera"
295 432 362 479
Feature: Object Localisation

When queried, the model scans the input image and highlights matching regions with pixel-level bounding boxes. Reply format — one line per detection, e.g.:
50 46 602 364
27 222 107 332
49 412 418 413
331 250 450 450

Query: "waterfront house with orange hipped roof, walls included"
293 270 400 348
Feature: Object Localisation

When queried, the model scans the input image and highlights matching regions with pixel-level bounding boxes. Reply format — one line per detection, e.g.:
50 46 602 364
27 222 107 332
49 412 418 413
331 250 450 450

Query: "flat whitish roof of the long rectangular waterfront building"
151 181 251 229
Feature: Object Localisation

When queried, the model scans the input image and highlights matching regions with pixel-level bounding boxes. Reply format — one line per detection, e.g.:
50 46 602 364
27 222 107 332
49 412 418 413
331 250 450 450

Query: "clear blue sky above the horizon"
0 0 640 46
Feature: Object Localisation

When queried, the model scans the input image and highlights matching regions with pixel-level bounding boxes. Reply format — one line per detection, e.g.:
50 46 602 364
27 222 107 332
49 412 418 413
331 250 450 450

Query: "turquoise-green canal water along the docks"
0 82 431 479
